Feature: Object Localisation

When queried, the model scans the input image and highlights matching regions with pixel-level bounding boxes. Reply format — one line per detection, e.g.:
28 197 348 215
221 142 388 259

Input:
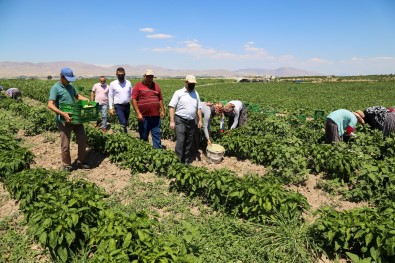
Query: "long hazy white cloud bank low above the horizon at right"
145 36 395 75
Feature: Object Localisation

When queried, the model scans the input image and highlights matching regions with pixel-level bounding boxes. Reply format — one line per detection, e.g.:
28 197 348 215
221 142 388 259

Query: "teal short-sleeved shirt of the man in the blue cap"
48 81 78 121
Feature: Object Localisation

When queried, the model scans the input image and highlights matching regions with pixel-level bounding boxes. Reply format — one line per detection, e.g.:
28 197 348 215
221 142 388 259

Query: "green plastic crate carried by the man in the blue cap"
59 100 99 124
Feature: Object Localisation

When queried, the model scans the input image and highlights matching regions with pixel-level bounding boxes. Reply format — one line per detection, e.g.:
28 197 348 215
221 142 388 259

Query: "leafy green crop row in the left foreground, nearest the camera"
0 124 198 262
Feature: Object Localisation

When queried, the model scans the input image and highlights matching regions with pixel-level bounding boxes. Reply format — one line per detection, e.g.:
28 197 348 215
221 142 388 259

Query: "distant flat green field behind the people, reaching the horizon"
4 76 395 113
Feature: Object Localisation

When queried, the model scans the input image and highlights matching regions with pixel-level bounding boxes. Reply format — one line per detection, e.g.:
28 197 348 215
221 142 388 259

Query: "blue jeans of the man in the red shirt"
138 116 162 149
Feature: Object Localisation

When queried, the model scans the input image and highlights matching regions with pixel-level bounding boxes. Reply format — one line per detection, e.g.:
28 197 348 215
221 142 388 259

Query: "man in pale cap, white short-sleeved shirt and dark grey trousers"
169 75 202 165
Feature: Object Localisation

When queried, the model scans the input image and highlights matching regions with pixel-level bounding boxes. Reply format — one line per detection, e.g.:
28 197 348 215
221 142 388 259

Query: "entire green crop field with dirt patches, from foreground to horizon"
0 77 395 263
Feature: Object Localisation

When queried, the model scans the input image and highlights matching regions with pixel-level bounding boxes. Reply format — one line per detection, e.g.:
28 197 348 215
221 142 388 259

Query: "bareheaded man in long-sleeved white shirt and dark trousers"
108 68 133 132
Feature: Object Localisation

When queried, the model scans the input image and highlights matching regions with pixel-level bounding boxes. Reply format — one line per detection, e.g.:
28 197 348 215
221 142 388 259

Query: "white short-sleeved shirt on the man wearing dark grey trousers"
169 87 201 120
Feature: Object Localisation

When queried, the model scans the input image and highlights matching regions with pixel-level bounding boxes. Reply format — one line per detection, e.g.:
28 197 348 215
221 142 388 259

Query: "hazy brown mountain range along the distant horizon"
0 61 323 78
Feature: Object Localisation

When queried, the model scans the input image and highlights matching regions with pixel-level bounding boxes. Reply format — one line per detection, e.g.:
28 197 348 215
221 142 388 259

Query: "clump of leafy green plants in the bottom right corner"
313 208 395 262
